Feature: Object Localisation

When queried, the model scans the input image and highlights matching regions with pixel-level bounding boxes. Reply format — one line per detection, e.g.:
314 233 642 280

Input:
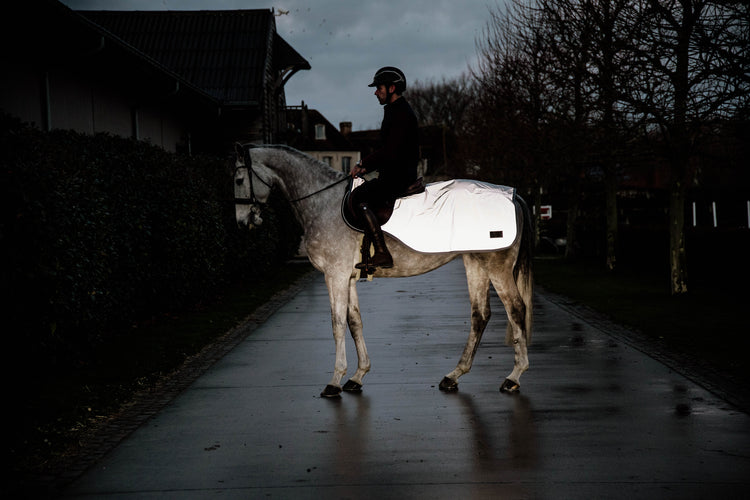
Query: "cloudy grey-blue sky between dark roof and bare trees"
62 0 504 130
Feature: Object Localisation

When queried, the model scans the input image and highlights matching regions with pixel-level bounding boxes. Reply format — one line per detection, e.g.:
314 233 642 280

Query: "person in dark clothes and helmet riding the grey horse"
351 66 419 269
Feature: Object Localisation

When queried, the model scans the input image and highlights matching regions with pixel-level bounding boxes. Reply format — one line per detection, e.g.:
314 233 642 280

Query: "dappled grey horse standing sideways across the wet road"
234 144 533 397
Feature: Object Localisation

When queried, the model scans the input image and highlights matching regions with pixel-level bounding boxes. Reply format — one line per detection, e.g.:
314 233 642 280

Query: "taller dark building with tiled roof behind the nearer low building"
80 9 310 151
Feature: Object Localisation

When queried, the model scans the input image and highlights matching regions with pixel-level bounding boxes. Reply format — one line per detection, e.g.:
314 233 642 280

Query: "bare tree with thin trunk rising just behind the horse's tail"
472 0 556 243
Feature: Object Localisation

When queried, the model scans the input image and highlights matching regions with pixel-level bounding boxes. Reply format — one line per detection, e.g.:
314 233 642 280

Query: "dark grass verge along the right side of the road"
534 258 750 386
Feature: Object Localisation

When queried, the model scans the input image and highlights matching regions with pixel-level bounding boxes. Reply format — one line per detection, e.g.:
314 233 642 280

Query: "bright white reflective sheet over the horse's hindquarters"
383 179 517 253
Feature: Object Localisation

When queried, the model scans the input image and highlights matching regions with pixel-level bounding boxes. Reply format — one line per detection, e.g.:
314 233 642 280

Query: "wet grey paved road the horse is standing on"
65 261 750 500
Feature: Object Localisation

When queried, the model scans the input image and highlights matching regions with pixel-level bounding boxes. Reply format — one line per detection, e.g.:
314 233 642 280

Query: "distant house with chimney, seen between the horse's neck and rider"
285 102 362 173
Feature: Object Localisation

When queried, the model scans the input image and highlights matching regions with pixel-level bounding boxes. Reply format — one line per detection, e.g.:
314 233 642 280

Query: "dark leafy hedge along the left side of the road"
0 115 300 368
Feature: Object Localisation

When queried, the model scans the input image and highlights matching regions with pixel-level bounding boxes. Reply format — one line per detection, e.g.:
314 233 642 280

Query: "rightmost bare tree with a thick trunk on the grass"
620 0 749 294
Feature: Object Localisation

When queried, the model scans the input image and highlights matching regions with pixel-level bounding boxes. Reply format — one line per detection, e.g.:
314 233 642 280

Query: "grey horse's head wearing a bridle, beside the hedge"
234 144 271 229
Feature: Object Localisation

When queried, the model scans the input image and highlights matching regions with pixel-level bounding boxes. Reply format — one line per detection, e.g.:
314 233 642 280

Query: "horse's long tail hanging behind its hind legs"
505 194 534 345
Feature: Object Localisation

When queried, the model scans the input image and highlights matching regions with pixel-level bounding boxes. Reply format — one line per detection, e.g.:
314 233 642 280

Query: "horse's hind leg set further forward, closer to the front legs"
440 255 491 391
